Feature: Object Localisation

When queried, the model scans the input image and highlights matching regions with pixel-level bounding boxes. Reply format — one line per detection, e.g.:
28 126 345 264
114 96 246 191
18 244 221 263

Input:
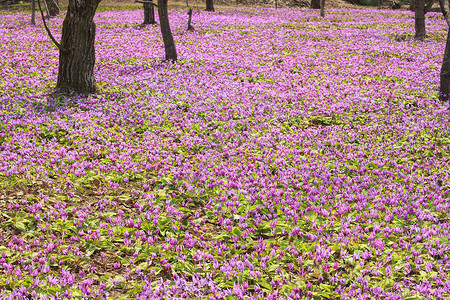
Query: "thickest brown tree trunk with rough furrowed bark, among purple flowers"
56 0 100 93
